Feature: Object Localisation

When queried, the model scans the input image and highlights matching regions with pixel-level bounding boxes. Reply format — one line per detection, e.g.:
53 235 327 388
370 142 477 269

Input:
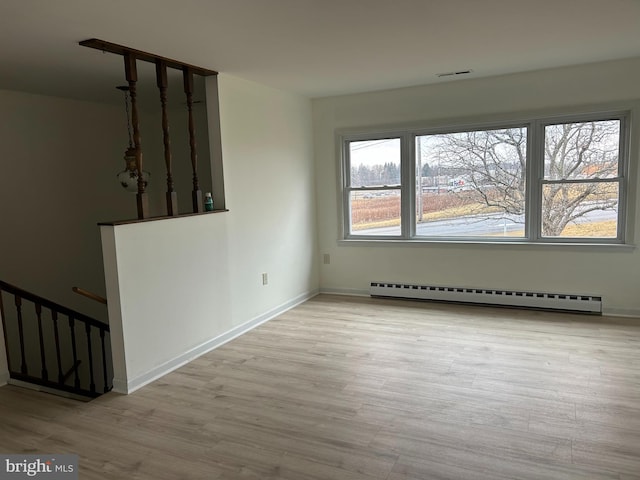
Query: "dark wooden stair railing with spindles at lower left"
0 281 113 398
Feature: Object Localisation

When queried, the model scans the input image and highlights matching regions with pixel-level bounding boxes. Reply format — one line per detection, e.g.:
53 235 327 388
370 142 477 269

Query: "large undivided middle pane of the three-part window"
416 127 527 237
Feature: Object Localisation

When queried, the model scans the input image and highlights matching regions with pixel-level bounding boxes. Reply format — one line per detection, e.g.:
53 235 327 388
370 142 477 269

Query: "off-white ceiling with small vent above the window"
0 0 640 101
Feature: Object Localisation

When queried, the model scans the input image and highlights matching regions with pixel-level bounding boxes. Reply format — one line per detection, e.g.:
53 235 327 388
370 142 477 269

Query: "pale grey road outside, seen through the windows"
355 210 617 237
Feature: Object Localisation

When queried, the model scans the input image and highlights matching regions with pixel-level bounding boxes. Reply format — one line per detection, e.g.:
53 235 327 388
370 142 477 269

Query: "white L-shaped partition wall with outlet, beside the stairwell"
102 75 318 393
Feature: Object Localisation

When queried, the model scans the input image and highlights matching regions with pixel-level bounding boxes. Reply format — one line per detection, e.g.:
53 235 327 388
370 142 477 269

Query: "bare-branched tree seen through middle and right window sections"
420 120 620 236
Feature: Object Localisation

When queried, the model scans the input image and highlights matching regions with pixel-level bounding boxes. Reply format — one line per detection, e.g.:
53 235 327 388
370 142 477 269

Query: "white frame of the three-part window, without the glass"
336 109 631 245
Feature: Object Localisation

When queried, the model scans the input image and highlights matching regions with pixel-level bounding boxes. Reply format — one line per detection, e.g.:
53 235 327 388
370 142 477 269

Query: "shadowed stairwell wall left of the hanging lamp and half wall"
0 90 136 320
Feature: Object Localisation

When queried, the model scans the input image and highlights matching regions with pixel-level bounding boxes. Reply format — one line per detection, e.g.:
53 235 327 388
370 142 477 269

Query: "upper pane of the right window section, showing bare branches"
544 120 620 180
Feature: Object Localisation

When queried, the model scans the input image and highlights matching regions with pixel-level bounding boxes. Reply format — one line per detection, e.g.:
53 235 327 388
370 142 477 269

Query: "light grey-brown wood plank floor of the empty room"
0 295 640 480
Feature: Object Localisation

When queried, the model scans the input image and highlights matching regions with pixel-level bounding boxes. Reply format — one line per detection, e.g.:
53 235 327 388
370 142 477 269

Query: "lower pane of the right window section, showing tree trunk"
542 182 619 238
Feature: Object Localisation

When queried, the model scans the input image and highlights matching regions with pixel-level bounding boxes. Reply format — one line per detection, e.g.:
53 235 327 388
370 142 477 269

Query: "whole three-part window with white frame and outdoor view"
342 112 628 243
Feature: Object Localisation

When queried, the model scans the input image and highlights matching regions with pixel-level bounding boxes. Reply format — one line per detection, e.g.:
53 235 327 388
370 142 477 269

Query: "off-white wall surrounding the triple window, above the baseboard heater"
313 59 640 315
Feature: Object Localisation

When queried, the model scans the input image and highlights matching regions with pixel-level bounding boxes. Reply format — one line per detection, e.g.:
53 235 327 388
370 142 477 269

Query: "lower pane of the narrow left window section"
350 189 401 235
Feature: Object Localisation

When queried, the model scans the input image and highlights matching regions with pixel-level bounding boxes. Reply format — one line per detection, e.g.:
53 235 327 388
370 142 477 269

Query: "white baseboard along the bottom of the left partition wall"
113 290 319 394
